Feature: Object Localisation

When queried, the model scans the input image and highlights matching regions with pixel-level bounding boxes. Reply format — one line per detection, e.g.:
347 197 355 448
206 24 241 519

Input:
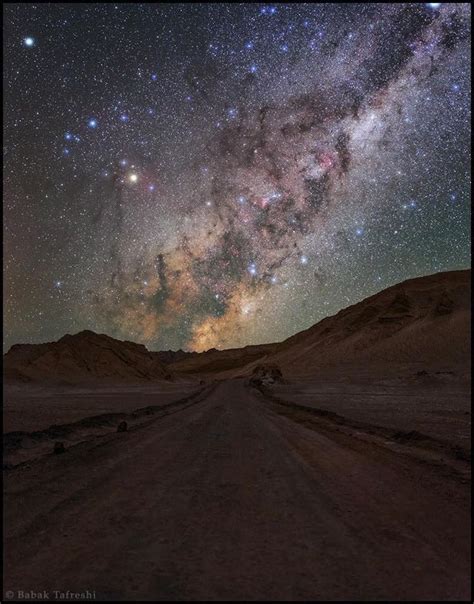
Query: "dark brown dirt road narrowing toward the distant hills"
4 380 470 601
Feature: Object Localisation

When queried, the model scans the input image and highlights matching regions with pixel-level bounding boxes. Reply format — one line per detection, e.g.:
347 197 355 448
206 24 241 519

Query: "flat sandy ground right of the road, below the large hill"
271 372 471 448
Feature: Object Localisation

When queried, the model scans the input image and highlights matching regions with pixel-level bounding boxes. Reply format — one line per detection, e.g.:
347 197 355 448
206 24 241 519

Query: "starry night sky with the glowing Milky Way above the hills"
4 3 470 351
